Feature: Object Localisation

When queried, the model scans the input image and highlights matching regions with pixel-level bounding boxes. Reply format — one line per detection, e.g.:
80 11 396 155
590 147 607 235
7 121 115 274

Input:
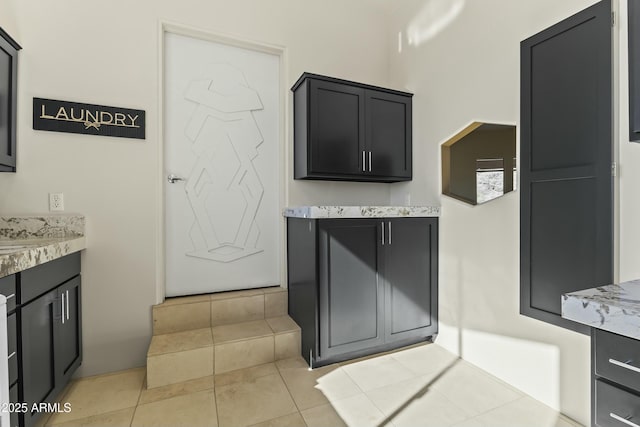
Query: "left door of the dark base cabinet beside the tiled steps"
318 219 384 358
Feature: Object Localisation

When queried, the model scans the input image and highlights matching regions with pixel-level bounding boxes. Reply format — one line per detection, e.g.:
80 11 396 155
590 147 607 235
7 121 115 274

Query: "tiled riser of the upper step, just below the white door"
153 288 287 335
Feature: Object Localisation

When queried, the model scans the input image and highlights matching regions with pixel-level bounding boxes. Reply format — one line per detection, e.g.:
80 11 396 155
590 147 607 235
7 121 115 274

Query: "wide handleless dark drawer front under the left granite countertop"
20 252 80 304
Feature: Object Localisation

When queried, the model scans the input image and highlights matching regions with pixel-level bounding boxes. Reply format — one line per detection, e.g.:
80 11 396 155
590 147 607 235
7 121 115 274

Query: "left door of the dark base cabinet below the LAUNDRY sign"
21 290 61 426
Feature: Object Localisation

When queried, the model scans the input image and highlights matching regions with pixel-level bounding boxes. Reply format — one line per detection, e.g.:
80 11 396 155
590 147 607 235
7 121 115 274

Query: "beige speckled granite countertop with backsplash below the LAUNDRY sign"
0 215 86 277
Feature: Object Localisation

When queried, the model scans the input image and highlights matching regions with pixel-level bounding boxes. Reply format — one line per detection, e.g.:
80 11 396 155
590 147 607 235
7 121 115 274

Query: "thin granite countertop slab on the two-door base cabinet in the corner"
282 206 440 219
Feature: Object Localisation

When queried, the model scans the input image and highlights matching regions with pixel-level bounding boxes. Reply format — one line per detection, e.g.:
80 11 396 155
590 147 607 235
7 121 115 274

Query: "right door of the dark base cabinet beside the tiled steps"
384 218 438 341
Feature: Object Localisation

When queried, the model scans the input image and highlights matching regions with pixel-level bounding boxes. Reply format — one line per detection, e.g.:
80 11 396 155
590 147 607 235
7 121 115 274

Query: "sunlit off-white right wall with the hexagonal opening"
390 0 604 425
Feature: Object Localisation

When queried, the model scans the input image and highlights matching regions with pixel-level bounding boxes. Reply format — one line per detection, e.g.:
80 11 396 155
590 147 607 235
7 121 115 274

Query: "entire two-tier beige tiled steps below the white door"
147 287 300 388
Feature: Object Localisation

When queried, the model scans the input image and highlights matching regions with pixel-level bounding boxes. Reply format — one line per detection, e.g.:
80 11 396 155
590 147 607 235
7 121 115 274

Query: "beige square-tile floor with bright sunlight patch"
40 344 577 427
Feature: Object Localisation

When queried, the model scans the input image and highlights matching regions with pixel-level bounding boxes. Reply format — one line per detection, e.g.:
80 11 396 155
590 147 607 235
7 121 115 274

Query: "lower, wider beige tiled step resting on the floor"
147 316 300 388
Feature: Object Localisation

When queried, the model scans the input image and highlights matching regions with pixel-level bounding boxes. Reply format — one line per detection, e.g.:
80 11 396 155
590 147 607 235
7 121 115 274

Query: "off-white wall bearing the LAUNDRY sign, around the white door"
0 0 389 375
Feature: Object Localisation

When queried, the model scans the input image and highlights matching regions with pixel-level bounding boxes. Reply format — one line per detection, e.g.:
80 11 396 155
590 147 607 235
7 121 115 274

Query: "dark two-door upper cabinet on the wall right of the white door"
291 73 413 182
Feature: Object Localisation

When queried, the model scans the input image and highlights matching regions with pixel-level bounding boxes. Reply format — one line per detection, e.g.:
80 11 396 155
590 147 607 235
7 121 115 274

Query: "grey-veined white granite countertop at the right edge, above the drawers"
562 280 640 340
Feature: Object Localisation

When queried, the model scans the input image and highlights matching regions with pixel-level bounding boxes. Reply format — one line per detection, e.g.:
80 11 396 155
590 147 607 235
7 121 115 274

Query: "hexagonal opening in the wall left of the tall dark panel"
441 122 517 205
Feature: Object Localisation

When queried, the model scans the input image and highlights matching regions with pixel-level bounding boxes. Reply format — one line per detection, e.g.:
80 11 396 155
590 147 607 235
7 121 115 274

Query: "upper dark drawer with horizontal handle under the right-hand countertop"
594 329 640 390
